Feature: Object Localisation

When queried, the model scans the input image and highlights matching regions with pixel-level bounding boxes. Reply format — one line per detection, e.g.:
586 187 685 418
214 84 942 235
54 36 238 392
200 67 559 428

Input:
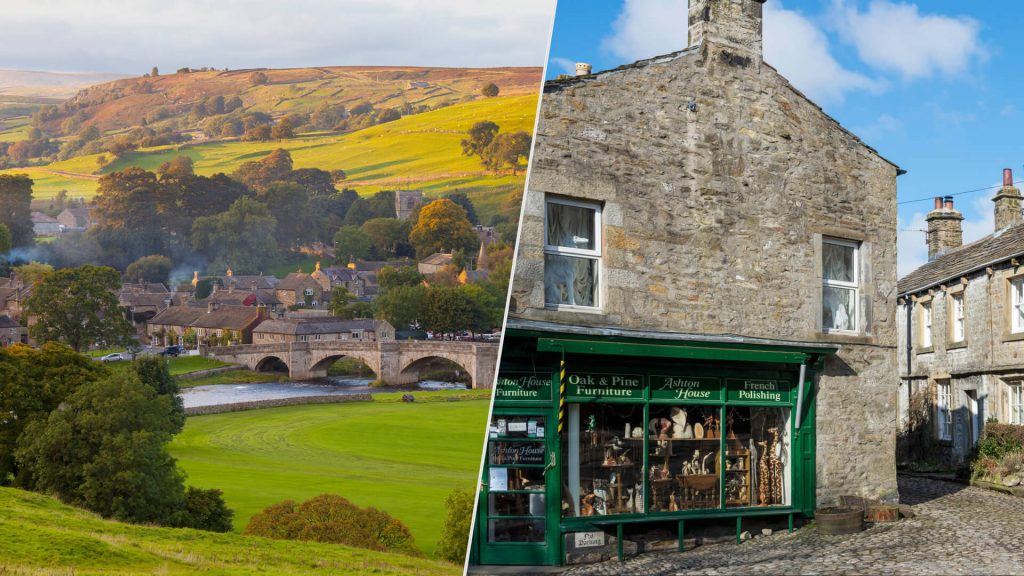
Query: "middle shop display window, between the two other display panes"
647 406 722 512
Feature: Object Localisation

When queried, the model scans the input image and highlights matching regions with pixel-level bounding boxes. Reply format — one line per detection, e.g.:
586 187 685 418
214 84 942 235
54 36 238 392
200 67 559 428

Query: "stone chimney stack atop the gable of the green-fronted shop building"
688 0 765 60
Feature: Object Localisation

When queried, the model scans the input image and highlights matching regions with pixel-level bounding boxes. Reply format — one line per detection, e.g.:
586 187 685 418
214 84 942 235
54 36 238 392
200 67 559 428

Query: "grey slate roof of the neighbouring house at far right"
896 218 1024 294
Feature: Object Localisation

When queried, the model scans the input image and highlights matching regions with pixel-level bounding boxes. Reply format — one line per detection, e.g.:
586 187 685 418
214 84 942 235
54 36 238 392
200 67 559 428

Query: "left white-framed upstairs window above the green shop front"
544 198 601 308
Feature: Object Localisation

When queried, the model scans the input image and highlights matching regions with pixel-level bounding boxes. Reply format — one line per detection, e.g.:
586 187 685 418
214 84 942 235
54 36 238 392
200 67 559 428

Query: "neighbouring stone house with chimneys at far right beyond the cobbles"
896 169 1024 464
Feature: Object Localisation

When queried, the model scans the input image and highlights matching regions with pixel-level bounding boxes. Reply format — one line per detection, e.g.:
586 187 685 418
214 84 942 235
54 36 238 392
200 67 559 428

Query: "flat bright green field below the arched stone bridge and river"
171 397 489 554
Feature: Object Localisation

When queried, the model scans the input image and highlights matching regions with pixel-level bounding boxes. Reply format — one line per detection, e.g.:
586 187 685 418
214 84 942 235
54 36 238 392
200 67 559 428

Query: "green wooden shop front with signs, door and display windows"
473 327 836 565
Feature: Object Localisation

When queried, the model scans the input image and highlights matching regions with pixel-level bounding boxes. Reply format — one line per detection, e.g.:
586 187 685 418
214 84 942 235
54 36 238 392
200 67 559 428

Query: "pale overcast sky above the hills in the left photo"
0 0 555 73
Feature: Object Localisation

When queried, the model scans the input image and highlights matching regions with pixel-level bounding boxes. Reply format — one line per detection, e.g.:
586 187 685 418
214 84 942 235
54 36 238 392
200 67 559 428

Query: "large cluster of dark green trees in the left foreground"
0 343 232 532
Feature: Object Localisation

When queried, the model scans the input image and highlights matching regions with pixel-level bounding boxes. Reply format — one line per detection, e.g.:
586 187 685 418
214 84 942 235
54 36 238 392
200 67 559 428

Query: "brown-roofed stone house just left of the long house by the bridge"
147 302 266 345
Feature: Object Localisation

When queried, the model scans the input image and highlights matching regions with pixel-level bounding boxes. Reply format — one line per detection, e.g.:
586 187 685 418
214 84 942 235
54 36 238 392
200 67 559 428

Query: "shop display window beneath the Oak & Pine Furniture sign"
562 404 647 517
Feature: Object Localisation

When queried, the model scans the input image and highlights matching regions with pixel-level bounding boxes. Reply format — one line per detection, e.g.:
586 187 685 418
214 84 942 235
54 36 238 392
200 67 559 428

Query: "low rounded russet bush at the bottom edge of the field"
245 494 419 557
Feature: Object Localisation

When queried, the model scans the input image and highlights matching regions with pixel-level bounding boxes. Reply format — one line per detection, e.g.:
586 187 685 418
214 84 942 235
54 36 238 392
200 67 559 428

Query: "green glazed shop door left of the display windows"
477 408 559 566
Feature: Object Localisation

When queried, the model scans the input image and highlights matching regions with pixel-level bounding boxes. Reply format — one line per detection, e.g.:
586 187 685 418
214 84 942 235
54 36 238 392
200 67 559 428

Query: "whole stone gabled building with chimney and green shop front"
473 0 900 564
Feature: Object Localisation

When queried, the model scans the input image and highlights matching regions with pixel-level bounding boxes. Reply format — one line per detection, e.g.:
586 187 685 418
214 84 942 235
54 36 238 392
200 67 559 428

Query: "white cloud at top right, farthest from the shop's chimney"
833 0 985 80
